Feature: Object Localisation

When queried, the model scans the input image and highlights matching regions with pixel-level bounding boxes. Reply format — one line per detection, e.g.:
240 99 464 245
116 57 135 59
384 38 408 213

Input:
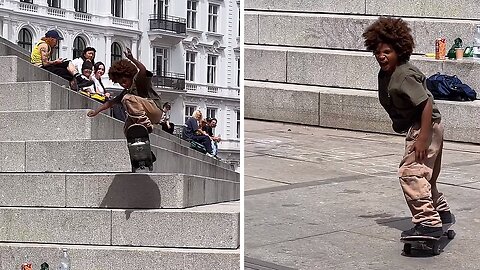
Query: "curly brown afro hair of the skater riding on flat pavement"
362 17 415 62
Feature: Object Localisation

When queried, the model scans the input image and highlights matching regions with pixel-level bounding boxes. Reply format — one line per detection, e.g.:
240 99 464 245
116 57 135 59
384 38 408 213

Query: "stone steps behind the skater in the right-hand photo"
244 0 480 143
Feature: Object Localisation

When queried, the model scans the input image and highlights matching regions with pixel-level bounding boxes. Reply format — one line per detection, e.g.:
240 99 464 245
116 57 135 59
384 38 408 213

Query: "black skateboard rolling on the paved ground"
400 216 455 255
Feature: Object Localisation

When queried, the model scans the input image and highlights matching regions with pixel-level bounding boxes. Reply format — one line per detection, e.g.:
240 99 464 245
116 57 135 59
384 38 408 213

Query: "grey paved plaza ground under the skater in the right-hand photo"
244 120 480 270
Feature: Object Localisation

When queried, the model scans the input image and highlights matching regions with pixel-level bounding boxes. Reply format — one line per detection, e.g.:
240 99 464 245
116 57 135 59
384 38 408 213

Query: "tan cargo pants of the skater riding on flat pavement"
398 122 450 227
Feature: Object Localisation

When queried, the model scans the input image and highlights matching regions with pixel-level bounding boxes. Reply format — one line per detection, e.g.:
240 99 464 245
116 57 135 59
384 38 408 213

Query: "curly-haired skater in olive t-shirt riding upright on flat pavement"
362 17 452 237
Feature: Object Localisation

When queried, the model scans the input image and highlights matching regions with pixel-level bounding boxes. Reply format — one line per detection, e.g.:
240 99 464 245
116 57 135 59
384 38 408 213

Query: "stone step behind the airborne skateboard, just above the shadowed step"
0 139 239 182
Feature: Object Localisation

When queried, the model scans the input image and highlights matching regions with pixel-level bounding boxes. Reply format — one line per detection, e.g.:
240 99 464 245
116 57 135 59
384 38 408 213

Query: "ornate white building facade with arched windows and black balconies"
0 0 240 167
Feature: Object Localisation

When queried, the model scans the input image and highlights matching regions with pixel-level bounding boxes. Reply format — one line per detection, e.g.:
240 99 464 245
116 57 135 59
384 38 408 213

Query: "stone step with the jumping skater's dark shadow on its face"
0 173 240 209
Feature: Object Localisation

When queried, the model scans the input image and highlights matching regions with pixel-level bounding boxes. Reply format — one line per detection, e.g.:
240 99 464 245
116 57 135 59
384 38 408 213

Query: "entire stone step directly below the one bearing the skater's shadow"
0 201 240 249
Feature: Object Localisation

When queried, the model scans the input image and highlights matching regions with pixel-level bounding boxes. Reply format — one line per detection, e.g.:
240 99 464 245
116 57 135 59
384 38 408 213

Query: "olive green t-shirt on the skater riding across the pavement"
378 62 441 133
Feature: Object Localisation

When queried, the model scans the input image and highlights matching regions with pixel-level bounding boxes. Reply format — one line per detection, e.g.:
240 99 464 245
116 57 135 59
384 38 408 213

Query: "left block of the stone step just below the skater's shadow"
0 207 111 245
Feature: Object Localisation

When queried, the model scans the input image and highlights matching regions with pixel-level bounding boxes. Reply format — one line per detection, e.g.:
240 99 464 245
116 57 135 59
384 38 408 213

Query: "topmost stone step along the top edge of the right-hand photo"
244 0 480 19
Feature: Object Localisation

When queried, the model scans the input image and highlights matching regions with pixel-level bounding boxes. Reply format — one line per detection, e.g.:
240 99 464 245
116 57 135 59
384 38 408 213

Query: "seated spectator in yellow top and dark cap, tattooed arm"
30 30 93 89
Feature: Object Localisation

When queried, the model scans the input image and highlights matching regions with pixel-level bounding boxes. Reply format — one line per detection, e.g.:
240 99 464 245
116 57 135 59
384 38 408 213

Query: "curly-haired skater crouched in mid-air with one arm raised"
87 49 163 158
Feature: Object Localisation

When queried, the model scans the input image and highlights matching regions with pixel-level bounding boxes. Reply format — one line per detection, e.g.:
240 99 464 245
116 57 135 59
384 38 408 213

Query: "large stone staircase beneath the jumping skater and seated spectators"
0 39 240 270
